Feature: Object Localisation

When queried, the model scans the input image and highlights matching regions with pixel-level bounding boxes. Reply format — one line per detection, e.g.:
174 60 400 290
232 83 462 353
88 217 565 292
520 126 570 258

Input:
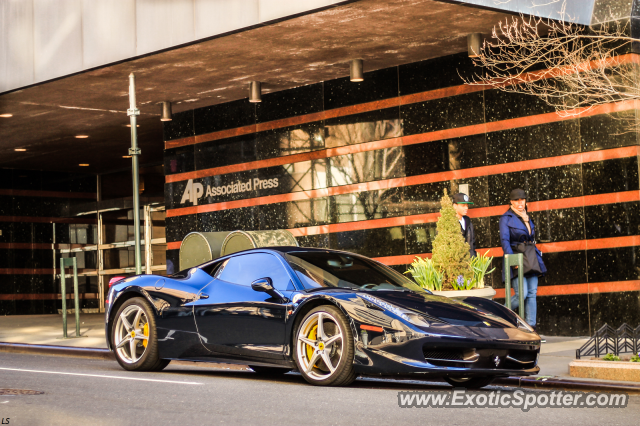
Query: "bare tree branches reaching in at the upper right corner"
466 0 640 131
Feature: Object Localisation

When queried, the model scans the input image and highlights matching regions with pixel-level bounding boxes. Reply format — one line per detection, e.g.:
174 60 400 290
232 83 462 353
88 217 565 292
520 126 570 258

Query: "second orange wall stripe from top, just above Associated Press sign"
165 101 635 183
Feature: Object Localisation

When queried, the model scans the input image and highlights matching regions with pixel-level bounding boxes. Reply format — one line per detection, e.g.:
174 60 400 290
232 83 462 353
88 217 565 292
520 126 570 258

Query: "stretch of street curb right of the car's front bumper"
492 377 640 394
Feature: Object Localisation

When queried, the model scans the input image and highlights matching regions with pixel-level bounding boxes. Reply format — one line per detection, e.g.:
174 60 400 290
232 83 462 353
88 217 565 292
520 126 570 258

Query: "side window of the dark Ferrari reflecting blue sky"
216 253 290 291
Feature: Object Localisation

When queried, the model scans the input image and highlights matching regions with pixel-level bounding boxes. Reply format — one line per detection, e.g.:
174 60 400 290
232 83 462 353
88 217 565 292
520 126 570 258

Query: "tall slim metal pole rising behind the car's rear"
127 73 142 275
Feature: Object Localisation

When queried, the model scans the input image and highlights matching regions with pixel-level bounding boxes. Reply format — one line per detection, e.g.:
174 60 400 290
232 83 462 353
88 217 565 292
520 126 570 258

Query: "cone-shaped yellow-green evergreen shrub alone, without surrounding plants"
431 189 473 290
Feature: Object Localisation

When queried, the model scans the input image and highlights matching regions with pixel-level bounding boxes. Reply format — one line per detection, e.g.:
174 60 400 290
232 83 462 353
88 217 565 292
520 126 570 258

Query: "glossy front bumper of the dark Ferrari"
354 326 540 377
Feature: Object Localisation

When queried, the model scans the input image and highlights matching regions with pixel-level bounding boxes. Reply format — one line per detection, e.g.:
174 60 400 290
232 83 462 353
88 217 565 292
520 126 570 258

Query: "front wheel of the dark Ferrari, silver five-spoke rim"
293 305 357 386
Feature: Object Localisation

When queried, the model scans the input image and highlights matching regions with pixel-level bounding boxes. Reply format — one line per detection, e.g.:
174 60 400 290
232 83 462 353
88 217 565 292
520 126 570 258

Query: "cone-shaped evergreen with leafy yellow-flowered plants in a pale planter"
406 189 496 299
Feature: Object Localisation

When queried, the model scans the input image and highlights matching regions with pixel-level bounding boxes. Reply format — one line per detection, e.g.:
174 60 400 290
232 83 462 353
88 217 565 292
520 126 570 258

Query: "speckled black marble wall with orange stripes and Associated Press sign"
164 50 640 335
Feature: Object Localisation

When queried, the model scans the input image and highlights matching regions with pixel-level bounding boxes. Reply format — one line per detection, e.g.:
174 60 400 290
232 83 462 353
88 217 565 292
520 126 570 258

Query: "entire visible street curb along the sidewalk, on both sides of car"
5 342 640 394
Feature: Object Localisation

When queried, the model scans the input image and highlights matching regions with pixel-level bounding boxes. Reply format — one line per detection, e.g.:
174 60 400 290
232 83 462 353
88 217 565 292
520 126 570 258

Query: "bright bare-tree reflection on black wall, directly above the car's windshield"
327 119 403 222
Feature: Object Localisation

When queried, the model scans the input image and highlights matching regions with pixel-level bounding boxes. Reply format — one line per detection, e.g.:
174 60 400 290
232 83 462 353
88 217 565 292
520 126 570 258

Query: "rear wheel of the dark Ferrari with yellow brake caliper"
111 297 170 371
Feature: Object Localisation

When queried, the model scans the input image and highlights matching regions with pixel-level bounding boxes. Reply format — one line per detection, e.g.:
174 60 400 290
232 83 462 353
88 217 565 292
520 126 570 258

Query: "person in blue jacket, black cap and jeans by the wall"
500 188 547 329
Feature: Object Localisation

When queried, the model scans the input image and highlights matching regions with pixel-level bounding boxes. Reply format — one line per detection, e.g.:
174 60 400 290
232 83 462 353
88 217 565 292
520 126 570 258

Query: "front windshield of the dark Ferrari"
286 251 425 293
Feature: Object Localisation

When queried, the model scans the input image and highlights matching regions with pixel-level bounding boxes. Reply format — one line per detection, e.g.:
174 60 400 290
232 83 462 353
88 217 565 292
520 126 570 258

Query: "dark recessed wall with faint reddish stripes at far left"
0 169 97 315
